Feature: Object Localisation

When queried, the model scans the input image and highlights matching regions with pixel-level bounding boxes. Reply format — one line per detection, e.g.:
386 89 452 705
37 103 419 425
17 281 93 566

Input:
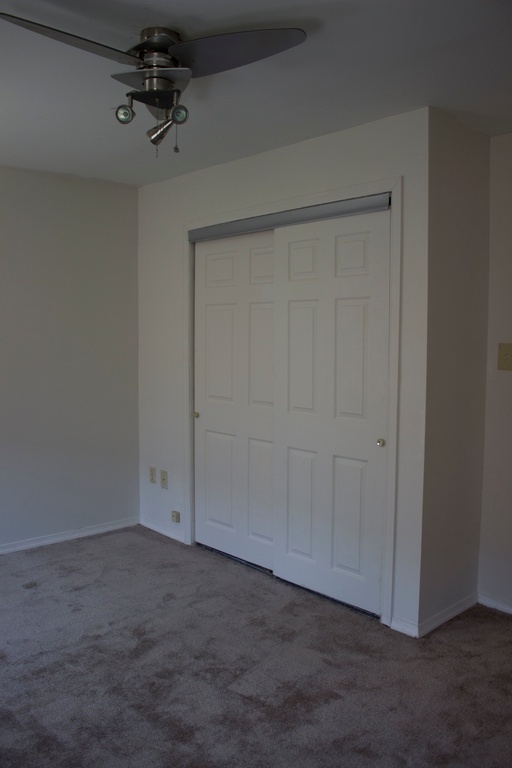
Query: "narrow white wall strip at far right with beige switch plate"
479 134 512 613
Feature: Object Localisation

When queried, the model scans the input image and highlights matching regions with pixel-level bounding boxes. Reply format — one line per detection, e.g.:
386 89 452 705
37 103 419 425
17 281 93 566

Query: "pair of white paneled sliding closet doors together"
195 212 389 614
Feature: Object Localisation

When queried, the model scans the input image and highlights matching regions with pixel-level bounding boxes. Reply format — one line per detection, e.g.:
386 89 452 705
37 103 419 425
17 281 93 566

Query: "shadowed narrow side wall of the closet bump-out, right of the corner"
420 109 489 632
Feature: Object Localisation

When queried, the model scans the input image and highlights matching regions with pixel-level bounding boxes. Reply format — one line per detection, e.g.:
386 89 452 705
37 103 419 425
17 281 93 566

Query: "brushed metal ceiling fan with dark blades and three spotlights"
0 13 306 151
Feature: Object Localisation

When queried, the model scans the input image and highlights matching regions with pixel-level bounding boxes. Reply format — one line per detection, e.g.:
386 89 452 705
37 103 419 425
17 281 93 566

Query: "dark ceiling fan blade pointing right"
169 28 306 77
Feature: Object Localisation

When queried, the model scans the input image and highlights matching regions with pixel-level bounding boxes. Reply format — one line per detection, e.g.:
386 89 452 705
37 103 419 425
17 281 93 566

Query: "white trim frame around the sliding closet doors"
183 176 403 626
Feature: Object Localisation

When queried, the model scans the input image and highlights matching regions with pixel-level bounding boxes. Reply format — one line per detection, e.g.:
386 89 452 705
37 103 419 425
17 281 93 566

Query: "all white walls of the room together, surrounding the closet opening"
0 110 512 634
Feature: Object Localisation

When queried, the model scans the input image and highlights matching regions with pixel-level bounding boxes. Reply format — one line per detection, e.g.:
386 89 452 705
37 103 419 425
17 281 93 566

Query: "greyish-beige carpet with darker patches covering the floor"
0 526 512 768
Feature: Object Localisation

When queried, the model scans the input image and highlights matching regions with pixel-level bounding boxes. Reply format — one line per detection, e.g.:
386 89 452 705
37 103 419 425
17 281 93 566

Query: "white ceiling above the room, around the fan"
0 0 512 185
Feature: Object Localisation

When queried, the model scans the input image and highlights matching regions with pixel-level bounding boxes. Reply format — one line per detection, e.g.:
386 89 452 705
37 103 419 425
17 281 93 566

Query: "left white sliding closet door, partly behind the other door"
195 232 274 568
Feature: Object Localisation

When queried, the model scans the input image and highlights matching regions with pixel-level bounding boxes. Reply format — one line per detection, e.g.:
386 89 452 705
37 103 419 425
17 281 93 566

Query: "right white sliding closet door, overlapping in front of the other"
274 211 389 613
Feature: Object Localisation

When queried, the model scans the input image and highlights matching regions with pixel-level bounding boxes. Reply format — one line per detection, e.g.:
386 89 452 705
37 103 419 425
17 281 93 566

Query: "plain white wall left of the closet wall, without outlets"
0 168 138 551
